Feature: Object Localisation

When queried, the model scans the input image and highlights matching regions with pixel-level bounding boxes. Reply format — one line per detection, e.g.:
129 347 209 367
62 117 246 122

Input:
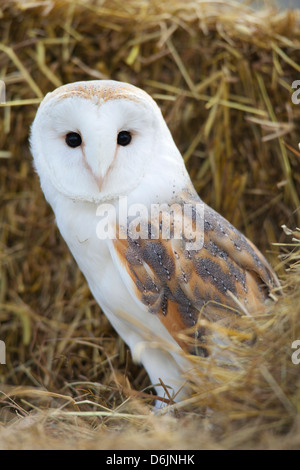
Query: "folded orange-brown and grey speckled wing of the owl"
112 189 280 354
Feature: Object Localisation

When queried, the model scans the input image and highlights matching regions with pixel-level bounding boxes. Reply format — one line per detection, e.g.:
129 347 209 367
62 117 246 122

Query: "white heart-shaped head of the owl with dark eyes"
30 80 183 206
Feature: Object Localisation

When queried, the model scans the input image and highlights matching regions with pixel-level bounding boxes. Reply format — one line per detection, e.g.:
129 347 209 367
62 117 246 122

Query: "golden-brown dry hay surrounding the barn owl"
0 0 300 449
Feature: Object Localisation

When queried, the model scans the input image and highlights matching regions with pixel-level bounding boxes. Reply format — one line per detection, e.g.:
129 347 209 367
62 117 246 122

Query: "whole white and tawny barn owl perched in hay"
30 80 279 401
